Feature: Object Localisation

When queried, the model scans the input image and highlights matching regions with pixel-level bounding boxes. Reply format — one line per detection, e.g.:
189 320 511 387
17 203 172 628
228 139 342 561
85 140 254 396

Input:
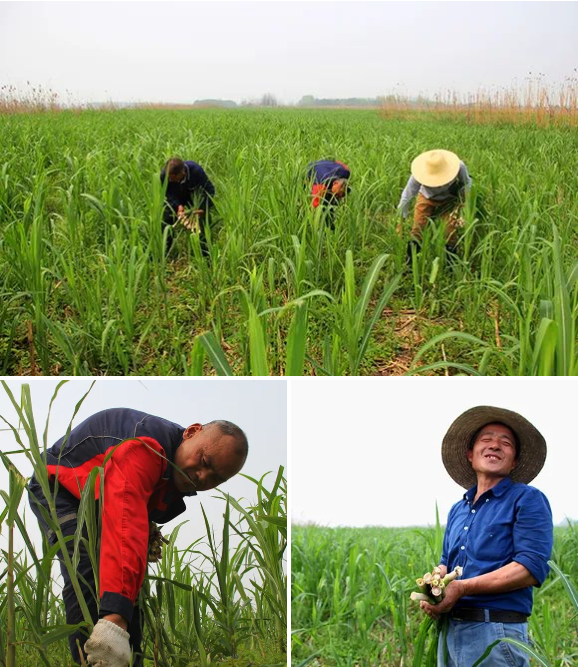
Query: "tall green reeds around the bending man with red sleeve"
0 383 287 666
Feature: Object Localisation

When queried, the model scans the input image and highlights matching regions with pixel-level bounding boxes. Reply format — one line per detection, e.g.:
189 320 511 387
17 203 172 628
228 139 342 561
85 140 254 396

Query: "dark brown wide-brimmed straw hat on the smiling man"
442 406 546 489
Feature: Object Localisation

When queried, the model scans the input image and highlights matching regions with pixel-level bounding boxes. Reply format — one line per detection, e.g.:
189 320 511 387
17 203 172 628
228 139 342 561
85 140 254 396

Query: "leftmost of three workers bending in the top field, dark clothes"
161 158 215 256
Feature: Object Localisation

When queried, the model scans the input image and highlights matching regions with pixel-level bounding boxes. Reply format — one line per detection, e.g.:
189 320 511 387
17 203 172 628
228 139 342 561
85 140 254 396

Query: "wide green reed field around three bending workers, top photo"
0 110 578 375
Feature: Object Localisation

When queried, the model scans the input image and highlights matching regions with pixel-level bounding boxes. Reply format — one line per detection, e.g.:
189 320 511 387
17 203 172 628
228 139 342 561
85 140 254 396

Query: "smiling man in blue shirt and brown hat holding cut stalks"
420 406 553 666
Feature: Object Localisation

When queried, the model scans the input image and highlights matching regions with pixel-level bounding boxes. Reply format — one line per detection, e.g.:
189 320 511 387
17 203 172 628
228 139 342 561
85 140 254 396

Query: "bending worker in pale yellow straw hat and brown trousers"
398 149 472 252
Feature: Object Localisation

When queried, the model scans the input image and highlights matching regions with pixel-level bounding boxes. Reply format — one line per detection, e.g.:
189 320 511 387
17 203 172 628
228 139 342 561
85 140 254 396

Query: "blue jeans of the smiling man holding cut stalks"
438 618 530 667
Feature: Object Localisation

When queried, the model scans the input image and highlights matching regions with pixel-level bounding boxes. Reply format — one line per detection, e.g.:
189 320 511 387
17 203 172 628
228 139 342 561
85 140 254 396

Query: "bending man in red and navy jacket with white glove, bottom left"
29 408 248 666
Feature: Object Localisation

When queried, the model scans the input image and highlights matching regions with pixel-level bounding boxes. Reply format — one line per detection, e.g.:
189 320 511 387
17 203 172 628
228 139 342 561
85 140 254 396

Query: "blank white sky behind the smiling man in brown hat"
290 377 578 526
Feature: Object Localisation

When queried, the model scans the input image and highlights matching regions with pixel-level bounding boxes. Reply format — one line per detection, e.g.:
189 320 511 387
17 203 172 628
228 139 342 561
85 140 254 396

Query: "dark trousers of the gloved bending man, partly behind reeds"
28 478 143 666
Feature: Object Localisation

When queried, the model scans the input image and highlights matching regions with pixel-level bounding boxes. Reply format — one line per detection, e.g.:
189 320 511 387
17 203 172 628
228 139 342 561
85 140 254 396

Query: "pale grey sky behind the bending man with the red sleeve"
0 378 287 560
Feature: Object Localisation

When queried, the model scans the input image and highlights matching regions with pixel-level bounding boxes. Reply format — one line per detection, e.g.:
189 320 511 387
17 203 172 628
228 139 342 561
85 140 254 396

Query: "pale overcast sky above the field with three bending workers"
0 1 578 102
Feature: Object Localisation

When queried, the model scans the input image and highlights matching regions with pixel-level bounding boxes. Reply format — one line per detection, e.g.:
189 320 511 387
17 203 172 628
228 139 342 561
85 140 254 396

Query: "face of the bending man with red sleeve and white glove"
173 424 245 494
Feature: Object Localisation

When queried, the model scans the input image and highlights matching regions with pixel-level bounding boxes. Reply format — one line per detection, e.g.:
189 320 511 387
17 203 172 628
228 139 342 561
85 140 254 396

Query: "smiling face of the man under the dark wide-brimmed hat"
467 423 517 478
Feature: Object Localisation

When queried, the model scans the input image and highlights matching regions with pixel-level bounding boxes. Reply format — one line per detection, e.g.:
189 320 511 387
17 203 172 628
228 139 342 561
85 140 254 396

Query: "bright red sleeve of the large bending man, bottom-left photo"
100 436 166 621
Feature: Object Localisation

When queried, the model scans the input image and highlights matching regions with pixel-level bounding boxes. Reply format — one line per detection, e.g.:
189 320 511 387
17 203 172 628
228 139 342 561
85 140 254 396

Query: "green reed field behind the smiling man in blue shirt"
291 523 578 666
